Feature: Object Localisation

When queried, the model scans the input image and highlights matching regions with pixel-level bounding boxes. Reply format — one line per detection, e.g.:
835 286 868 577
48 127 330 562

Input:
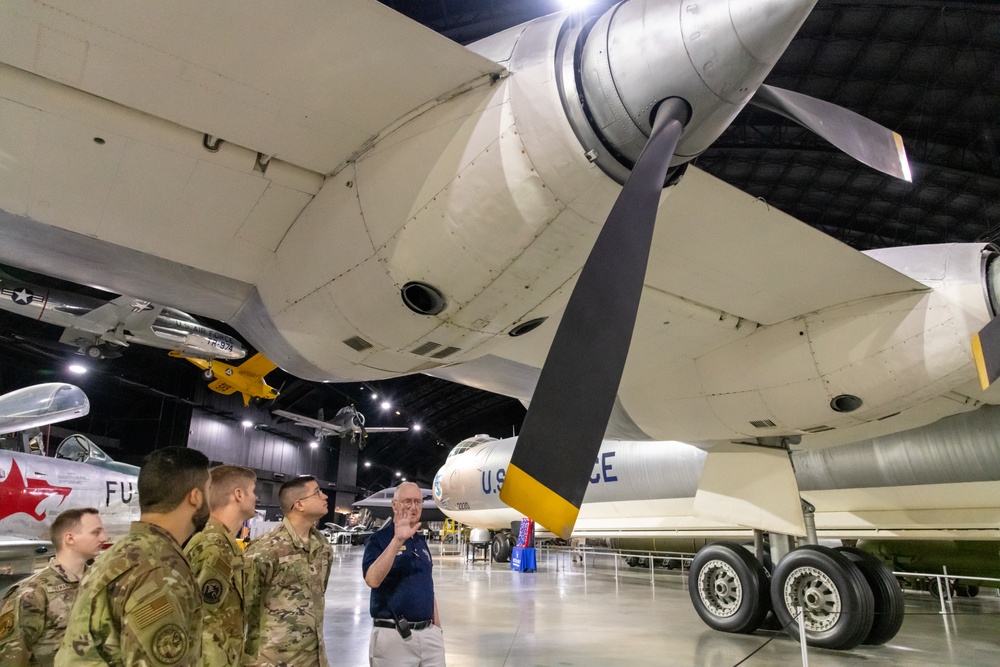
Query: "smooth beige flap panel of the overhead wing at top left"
0 0 503 174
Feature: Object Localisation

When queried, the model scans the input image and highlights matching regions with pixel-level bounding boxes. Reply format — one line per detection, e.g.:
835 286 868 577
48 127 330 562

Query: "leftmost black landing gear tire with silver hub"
688 542 771 634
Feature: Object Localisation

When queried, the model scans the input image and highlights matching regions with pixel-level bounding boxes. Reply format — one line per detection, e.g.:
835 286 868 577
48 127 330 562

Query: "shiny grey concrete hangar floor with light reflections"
326 546 1000 667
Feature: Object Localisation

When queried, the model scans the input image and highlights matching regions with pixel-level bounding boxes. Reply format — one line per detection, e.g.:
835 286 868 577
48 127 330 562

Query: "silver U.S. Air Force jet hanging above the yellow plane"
0 271 246 359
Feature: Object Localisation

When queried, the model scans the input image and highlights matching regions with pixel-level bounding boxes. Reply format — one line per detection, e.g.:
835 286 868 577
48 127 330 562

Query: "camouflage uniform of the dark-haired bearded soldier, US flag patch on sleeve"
56 521 201 667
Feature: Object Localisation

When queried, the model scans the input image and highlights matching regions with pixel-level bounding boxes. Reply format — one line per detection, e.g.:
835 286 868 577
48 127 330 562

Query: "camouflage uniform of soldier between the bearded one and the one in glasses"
184 519 247 667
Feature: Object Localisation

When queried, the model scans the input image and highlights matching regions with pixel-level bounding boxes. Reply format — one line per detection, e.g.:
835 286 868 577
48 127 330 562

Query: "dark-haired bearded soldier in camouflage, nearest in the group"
56 447 209 667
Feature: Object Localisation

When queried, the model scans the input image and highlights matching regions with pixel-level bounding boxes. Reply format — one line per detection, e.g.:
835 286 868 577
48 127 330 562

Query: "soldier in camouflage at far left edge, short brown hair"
0 507 106 667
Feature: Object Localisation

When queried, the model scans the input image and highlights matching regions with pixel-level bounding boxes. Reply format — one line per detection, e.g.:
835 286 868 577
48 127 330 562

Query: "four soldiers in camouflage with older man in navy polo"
0 447 445 667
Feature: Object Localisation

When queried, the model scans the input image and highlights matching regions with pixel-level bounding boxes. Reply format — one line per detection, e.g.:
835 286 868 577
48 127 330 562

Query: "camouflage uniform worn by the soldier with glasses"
246 518 333 667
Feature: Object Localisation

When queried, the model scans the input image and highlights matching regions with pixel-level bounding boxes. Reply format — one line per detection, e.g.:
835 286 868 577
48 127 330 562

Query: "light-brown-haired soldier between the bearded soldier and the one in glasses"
184 466 257 667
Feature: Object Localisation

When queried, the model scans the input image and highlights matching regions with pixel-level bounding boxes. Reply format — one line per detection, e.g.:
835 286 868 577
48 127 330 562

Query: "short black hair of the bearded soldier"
139 447 208 514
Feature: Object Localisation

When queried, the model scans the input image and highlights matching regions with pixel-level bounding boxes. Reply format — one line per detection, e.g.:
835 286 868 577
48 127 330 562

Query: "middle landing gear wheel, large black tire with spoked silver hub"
771 545 875 650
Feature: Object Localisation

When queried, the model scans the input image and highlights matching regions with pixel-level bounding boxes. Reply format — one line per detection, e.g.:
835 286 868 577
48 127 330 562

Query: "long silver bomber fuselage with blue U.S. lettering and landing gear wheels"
433 406 1000 643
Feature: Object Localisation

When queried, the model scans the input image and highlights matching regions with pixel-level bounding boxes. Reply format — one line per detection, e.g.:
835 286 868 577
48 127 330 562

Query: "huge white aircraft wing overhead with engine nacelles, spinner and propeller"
0 0 1000 647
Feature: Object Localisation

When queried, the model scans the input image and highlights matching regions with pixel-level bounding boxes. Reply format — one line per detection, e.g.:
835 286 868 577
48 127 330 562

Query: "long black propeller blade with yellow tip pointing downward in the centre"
500 99 689 539
